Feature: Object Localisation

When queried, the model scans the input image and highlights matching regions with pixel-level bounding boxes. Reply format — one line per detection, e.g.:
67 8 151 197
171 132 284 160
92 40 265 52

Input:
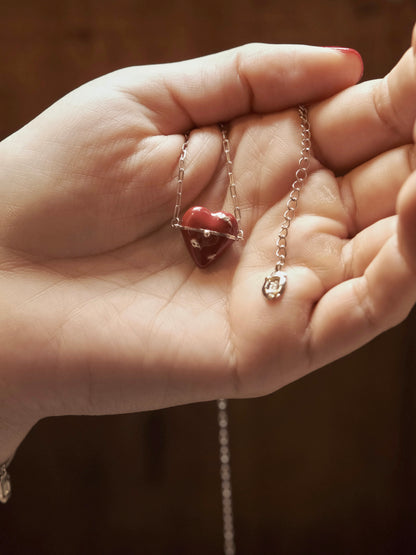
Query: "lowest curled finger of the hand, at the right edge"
309 234 416 369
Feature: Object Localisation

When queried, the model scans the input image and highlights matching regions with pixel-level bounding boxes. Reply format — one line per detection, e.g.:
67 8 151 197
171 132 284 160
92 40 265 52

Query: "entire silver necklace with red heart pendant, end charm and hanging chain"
171 106 312 555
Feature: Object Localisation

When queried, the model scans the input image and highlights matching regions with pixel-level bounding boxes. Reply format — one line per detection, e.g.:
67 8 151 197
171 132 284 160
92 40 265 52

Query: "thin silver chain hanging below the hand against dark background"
217 399 236 555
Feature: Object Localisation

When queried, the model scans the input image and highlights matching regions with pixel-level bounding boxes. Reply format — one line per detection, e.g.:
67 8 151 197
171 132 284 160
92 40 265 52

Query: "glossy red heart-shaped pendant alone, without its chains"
180 206 238 268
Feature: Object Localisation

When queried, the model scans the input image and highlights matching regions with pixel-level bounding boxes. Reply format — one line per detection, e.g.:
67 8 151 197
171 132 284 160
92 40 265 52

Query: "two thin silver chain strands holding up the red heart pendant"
171 123 244 241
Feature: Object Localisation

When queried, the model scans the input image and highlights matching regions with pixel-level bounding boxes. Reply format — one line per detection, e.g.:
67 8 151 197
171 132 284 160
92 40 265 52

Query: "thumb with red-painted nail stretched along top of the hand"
110 44 363 134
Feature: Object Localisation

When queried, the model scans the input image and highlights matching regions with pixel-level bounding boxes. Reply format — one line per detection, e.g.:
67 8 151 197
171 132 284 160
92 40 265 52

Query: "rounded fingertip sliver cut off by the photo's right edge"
397 169 416 274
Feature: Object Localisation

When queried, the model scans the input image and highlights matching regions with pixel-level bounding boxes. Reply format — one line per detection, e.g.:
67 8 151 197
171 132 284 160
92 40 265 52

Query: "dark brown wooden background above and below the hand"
0 0 416 555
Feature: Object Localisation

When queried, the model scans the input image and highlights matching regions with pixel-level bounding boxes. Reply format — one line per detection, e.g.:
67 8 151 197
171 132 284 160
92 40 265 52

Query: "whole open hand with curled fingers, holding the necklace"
0 30 416 460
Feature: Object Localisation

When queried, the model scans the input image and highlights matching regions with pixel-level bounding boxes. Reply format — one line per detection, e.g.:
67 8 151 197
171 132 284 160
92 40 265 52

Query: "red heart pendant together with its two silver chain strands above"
171 124 244 268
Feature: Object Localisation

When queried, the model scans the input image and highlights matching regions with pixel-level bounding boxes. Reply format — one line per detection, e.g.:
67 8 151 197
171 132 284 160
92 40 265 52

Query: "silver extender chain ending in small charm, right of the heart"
262 106 311 300
